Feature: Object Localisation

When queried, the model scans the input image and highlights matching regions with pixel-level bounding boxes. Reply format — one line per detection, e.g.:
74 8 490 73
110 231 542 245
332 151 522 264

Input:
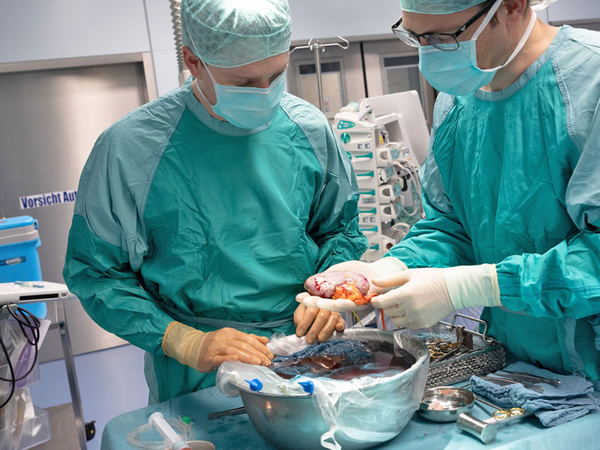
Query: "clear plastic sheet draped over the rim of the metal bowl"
217 329 429 450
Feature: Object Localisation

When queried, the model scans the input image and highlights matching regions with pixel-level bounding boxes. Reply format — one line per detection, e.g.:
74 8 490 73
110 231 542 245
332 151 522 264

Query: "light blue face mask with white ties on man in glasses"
419 0 537 95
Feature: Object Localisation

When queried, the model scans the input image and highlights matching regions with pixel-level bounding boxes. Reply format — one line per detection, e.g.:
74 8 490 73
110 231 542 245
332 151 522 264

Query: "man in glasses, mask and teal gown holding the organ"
298 0 600 387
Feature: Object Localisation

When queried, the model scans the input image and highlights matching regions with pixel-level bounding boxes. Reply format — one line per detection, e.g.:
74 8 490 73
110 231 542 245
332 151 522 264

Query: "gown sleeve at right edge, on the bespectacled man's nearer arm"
496 104 600 319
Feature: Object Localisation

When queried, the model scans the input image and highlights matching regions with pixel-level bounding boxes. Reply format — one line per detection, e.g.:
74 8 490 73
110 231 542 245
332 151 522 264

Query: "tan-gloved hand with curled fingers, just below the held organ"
294 303 346 344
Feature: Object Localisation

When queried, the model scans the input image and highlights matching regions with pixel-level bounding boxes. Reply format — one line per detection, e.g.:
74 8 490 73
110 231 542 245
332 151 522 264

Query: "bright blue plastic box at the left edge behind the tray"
0 216 47 319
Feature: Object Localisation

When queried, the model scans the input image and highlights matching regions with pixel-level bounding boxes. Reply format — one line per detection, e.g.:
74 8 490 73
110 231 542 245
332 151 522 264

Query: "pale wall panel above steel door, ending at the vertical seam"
0 0 150 63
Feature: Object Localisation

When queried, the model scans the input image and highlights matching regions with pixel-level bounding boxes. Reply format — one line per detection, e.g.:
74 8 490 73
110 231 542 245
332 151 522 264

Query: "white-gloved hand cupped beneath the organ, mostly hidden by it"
296 258 406 312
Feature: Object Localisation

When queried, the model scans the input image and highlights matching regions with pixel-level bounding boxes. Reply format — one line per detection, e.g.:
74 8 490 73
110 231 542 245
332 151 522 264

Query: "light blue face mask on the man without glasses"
196 65 286 130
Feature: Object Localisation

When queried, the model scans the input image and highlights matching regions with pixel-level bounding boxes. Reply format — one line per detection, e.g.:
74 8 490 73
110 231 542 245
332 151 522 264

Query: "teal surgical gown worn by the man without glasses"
64 81 367 402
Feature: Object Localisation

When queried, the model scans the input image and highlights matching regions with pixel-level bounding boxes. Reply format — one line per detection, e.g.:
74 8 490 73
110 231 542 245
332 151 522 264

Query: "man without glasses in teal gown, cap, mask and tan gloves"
64 0 367 403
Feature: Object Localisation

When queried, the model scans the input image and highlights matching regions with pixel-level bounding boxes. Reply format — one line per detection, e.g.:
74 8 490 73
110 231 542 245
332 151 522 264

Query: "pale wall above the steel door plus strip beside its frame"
0 0 178 95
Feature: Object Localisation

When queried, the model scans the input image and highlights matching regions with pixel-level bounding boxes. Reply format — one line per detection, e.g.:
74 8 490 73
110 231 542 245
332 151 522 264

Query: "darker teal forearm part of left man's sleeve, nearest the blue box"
63 214 173 354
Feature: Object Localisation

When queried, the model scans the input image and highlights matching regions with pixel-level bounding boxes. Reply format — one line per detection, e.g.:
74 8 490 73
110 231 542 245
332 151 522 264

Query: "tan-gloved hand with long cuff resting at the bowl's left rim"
162 321 273 373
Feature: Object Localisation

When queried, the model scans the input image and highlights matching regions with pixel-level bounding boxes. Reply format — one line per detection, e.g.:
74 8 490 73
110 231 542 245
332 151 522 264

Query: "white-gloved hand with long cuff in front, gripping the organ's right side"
371 264 502 329
